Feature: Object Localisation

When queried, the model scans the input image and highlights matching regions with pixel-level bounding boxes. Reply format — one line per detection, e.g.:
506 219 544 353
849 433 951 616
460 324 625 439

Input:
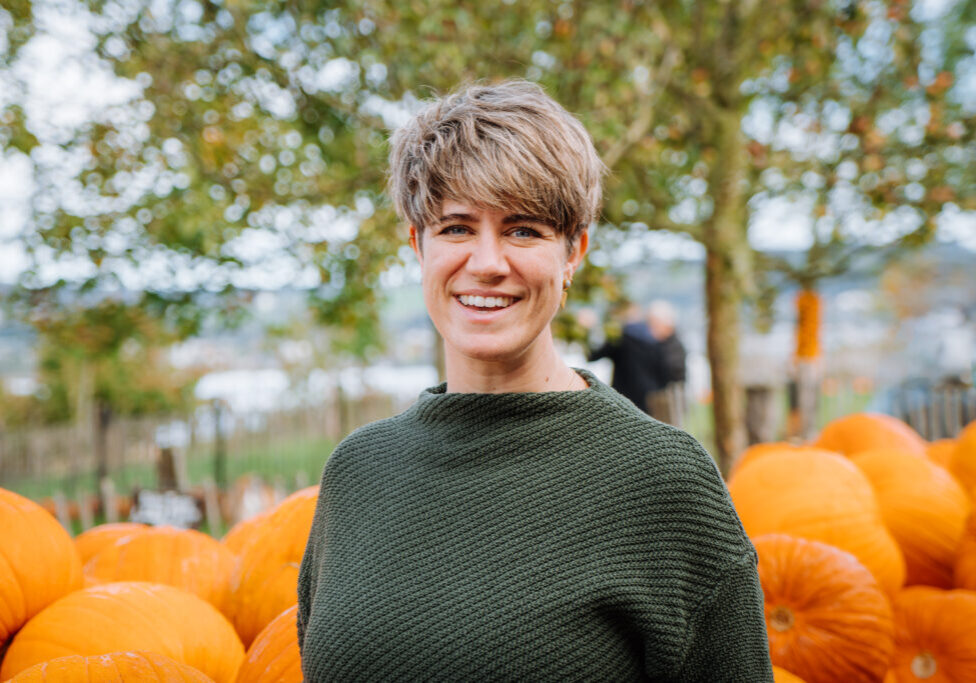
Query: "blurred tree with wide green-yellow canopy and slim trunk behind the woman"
0 0 976 470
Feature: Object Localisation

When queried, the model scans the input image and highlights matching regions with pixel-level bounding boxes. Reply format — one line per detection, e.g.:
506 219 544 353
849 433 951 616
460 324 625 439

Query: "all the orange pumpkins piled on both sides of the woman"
0 414 976 683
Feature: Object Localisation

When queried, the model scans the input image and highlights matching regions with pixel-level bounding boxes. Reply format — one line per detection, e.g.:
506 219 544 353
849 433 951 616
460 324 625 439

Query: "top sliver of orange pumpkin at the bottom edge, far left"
9 652 213 683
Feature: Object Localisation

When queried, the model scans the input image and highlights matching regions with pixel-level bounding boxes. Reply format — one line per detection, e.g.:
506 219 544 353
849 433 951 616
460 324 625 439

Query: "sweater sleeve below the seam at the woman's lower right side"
676 553 773 683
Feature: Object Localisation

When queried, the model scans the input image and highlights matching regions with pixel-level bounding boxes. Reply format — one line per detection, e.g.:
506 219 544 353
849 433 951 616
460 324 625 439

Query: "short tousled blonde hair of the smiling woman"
389 80 605 245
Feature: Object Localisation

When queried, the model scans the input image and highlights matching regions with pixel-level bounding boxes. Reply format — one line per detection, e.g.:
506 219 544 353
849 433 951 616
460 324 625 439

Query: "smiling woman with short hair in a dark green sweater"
298 82 773 683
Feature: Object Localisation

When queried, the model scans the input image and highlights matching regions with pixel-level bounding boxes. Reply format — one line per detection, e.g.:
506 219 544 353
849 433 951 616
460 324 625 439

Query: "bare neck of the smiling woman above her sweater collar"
444 337 588 394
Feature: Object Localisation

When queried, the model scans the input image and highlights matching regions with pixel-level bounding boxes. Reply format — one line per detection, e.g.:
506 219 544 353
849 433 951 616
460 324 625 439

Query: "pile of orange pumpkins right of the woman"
728 413 976 683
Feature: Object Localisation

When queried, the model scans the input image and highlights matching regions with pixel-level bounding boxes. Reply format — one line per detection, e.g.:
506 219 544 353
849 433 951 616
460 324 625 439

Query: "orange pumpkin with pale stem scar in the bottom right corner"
891 586 976 683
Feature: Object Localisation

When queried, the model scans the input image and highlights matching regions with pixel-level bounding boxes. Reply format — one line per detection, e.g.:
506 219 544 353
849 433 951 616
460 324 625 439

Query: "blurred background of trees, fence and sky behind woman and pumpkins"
0 0 976 533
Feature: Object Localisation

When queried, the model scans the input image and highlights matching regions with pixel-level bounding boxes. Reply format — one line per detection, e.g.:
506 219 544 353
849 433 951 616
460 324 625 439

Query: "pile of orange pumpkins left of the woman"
0 486 318 683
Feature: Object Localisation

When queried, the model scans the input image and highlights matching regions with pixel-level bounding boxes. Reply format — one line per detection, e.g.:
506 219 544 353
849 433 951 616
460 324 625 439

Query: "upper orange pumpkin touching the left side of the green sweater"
226 486 318 645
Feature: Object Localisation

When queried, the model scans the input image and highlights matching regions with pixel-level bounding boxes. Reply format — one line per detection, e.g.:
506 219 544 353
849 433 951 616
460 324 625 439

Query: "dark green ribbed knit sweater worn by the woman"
298 371 773 683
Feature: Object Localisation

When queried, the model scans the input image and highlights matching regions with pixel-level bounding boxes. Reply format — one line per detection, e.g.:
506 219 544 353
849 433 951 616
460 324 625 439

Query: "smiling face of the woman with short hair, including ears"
410 200 587 361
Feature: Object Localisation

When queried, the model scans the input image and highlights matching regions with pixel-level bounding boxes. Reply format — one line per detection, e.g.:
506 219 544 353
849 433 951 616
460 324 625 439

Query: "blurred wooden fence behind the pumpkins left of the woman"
0 393 404 508
